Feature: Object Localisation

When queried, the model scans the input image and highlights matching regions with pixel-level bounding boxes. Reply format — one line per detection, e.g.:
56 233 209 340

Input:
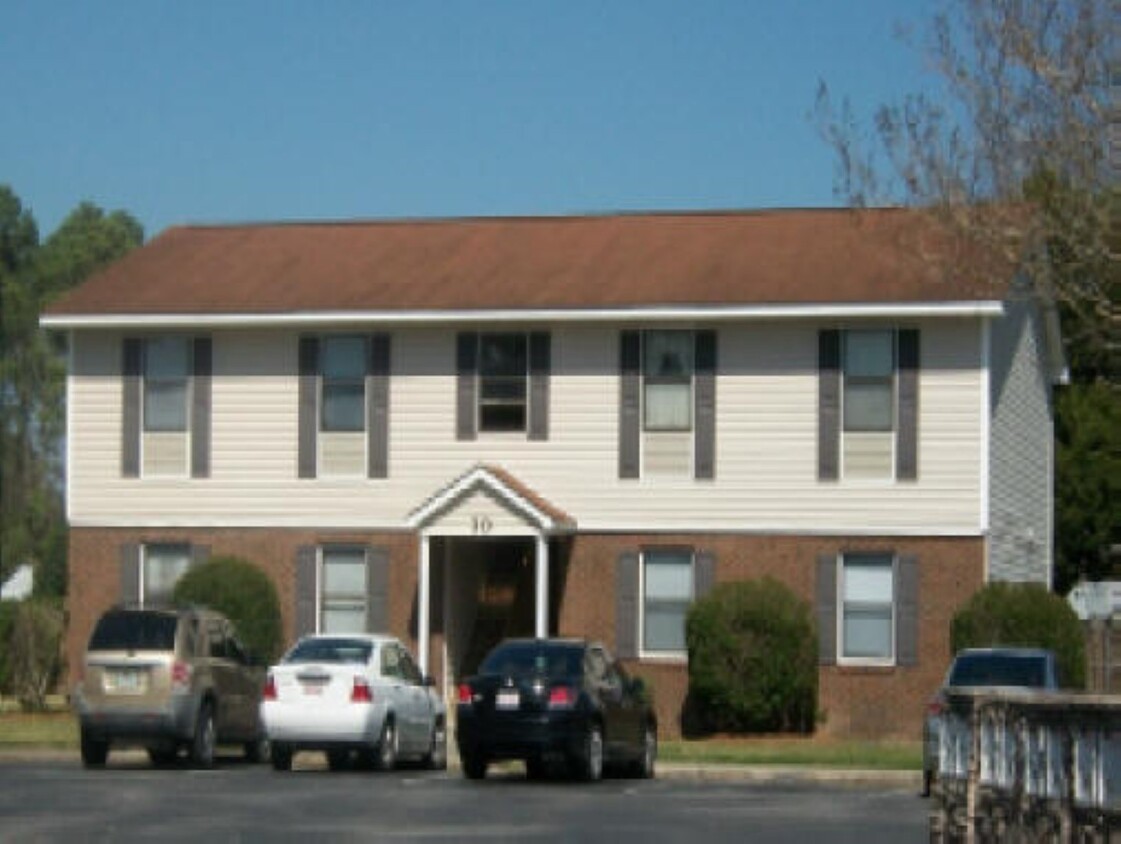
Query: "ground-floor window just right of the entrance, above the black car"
640 548 694 657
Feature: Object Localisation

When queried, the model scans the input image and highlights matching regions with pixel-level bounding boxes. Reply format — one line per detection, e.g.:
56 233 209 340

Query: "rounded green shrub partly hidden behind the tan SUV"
173 557 281 662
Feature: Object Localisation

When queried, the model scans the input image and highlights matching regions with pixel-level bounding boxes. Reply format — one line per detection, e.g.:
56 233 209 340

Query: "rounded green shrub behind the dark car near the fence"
949 583 1086 688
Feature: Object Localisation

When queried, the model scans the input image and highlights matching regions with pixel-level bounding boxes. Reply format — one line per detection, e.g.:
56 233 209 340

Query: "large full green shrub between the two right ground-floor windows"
685 577 817 732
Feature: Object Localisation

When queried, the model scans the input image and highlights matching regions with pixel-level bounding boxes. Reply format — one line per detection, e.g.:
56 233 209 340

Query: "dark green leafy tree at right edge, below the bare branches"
1055 381 1121 593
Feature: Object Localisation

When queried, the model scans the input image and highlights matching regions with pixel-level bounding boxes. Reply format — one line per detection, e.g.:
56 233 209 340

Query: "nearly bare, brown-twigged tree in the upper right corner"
818 0 1121 367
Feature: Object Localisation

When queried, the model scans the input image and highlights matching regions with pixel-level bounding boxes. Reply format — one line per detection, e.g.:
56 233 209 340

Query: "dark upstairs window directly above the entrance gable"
479 333 529 432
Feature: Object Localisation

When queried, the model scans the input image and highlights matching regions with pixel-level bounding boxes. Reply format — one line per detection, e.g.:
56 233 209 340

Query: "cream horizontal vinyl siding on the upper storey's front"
67 317 983 536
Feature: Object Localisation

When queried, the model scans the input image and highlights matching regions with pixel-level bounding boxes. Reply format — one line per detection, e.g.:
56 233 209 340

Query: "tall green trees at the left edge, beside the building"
0 185 143 595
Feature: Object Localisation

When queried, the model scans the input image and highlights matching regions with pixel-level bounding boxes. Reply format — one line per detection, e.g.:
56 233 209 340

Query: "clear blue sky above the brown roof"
0 0 932 236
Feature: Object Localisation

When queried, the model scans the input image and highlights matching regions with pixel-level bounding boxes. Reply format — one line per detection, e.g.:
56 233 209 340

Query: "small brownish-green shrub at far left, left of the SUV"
4 597 66 712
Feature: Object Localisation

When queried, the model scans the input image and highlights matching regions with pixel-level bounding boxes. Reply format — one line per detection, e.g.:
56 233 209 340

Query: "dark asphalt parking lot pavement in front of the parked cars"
0 753 928 844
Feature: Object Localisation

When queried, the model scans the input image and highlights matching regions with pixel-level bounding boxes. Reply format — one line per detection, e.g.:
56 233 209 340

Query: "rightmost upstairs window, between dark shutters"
842 328 896 433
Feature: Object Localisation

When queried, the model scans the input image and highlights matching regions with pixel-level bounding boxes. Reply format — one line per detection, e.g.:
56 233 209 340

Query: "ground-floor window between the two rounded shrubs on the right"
837 553 896 665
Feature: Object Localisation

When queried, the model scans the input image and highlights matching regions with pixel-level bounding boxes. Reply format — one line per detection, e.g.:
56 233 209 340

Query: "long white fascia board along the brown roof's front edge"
39 300 1003 328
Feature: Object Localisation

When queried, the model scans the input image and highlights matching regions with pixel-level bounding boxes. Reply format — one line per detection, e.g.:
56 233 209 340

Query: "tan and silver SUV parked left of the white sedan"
75 609 267 768
